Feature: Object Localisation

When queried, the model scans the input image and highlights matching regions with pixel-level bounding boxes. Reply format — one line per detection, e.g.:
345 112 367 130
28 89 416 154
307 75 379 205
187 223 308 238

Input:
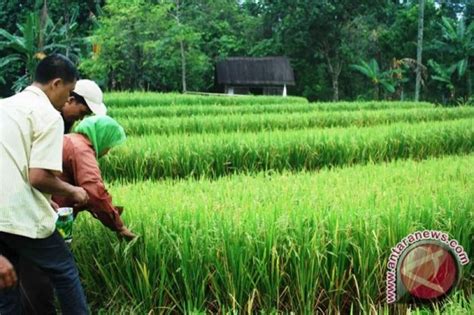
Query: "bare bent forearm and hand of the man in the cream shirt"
29 168 89 207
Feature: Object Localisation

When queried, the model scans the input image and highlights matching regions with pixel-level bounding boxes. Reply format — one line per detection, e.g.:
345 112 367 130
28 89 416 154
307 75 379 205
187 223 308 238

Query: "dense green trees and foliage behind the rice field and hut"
0 0 474 104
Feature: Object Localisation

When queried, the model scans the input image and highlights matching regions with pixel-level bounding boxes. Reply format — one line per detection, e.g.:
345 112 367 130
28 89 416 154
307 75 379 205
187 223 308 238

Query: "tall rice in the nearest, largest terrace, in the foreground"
73 157 474 314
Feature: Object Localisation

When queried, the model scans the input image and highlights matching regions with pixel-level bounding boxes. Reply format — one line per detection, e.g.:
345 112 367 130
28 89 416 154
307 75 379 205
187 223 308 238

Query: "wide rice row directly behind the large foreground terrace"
101 119 474 180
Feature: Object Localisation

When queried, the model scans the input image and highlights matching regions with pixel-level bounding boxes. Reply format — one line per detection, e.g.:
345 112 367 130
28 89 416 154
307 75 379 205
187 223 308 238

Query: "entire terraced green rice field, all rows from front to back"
73 93 474 314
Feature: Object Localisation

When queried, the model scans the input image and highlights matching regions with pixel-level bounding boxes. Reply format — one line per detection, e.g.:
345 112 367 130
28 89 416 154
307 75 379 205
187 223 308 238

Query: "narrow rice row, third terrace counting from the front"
119 107 474 135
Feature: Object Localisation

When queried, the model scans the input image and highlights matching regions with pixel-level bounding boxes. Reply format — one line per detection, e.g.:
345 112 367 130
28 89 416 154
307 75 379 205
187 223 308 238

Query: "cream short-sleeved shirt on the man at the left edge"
0 86 64 238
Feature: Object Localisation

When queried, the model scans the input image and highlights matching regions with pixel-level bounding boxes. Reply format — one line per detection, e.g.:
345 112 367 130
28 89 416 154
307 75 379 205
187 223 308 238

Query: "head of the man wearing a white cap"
61 80 107 133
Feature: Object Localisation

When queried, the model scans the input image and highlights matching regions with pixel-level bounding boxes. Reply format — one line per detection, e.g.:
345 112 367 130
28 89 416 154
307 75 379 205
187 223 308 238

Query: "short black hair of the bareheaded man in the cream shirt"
35 54 79 84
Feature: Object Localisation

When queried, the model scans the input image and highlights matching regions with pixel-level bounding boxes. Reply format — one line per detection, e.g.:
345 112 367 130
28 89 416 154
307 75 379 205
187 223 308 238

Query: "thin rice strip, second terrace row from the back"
108 102 435 118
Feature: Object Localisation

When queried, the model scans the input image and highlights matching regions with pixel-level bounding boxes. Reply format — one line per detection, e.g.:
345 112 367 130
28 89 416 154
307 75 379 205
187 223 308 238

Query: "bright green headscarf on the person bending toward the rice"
74 115 126 158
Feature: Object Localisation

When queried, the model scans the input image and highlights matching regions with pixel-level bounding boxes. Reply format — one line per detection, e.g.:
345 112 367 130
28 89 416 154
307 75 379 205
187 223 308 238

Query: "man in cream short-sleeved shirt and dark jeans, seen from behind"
0 54 88 315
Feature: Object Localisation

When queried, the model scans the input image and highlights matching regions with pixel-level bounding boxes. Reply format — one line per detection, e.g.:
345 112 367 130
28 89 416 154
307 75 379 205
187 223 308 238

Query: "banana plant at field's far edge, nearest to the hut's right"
351 59 396 100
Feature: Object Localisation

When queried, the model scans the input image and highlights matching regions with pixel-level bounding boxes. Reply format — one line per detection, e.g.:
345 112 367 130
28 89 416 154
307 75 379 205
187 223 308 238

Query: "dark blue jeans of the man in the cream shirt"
0 231 89 315
